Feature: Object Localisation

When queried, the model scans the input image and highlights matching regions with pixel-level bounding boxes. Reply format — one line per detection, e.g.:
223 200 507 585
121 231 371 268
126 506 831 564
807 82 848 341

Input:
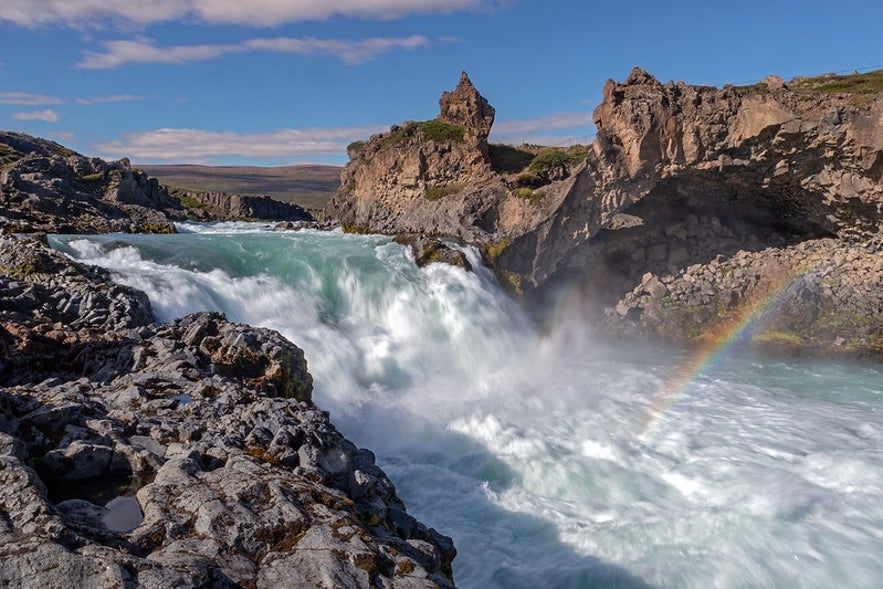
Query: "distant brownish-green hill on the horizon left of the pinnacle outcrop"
138 165 341 209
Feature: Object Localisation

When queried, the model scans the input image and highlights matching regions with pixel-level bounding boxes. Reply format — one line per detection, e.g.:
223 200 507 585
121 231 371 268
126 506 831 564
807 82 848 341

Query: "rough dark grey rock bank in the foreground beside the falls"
0 236 455 588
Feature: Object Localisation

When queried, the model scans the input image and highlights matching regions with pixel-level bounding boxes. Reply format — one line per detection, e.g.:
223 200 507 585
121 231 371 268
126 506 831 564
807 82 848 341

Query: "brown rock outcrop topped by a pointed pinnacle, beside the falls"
324 72 560 243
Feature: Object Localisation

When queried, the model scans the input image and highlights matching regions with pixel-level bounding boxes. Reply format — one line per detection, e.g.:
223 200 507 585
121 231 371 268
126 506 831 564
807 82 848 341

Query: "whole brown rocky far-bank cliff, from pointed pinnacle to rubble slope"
329 68 883 355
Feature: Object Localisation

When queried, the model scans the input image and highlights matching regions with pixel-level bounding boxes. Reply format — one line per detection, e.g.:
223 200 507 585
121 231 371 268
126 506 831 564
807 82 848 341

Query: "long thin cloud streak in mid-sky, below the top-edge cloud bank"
77 35 430 69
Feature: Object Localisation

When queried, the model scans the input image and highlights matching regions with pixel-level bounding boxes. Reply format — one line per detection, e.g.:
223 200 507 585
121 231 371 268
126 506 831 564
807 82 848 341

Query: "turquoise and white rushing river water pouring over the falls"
52 224 883 588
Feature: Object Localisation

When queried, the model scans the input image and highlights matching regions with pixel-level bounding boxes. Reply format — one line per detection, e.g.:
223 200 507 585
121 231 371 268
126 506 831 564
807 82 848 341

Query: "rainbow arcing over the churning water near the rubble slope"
638 267 809 443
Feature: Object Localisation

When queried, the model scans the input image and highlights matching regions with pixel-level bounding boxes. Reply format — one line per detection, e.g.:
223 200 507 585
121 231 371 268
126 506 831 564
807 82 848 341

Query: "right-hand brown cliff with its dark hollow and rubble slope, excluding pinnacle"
495 68 883 356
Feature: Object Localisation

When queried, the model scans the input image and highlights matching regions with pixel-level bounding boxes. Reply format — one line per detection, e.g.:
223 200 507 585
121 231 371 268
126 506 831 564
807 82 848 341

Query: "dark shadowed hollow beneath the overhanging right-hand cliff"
550 173 834 312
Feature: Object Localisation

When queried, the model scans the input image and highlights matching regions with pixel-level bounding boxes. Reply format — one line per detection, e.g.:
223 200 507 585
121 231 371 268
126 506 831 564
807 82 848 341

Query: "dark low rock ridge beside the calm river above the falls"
0 131 312 233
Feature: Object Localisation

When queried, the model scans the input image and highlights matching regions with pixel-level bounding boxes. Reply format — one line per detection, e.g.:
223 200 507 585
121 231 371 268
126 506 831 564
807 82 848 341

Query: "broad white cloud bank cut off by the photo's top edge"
0 0 490 28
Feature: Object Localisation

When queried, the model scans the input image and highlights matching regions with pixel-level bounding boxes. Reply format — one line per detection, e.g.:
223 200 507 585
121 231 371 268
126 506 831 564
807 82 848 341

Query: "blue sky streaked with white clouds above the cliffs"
0 0 883 165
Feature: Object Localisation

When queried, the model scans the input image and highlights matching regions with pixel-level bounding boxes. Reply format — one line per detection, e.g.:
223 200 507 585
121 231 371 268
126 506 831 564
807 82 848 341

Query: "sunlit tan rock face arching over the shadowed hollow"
501 68 883 286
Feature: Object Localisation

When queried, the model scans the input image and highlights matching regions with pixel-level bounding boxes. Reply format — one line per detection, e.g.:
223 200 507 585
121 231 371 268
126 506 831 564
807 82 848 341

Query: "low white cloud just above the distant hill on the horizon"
95 126 386 163
